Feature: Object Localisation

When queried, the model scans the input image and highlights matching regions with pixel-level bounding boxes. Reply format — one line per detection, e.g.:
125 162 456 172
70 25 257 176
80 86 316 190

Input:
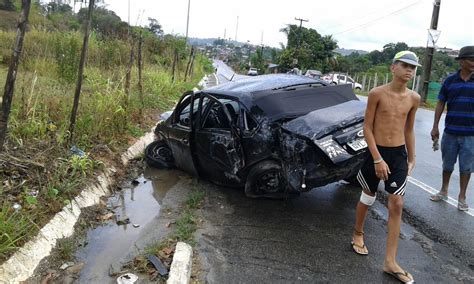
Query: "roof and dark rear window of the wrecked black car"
201 74 358 120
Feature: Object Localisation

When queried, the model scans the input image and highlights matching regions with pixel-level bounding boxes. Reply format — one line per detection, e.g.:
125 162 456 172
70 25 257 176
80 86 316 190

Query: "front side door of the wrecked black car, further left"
168 91 199 176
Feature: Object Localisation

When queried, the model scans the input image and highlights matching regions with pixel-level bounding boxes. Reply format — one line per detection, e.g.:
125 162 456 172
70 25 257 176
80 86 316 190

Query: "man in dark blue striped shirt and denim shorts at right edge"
430 46 474 211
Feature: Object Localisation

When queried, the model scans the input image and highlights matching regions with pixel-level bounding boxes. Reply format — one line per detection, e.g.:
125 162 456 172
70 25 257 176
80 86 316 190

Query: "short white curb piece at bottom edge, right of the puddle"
166 242 193 284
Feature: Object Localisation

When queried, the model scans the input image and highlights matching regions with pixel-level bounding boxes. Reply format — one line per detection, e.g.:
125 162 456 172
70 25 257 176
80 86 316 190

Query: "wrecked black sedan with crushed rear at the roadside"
145 74 367 197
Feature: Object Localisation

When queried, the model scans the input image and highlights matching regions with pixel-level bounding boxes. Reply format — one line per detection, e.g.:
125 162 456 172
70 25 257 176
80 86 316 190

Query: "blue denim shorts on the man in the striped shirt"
441 132 474 174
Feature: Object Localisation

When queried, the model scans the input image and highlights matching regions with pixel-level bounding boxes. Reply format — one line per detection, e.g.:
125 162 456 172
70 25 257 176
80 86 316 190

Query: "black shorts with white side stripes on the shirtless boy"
357 145 408 196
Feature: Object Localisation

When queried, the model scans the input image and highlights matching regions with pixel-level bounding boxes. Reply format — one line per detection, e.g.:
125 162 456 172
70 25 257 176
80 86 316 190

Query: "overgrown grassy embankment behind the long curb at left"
0 29 212 263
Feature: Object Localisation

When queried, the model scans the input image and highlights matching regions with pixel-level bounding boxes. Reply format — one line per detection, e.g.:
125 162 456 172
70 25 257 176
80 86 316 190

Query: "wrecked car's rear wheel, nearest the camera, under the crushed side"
245 160 286 198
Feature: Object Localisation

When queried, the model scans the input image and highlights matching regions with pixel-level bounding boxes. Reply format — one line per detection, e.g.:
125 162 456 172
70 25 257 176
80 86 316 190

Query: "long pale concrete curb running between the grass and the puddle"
0 132 154 283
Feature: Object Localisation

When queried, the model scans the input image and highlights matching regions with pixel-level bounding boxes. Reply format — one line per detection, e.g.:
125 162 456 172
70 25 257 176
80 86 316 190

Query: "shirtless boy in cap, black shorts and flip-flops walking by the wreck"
351 51 421 283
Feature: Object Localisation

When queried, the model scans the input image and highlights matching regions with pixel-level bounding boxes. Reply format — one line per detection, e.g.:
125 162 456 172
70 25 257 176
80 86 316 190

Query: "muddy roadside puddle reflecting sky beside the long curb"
75 168 179 283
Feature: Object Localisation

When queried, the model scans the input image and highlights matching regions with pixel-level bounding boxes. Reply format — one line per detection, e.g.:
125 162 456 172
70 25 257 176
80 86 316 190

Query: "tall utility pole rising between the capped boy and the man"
421 0 441 102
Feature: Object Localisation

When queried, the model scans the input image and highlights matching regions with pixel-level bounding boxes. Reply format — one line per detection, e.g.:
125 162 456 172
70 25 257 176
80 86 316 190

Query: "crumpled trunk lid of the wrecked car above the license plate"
282 100 366 141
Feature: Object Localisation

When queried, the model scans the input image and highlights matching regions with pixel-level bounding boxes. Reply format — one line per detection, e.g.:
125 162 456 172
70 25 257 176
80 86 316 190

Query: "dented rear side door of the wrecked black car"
195 94 244 184
